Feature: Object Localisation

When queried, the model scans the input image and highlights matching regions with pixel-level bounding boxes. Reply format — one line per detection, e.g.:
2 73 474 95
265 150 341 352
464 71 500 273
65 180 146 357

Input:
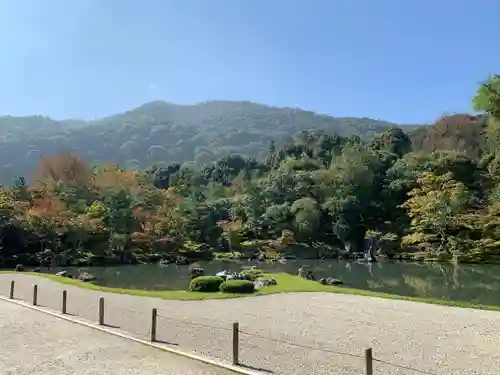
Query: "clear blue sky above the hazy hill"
0 0 500 123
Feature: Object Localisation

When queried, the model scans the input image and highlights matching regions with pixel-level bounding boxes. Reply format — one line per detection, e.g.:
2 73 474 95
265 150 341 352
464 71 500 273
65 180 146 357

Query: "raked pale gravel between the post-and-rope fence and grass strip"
0 274 500 375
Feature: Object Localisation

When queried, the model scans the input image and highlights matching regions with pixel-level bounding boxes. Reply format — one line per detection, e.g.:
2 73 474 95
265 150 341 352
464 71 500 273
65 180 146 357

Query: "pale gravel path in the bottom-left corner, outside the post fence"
0 301 231 375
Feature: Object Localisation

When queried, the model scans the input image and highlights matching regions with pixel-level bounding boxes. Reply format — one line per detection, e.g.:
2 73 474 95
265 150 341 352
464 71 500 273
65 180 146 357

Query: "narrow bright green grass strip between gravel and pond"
0 271 500 311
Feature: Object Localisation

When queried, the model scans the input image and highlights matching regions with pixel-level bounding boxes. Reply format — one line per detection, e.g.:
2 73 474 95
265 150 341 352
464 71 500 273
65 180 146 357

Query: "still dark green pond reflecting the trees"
57 260 500 306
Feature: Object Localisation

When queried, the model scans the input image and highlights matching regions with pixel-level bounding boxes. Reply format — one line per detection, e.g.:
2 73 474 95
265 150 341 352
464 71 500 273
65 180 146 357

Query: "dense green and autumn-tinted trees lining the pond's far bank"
0 76 500 266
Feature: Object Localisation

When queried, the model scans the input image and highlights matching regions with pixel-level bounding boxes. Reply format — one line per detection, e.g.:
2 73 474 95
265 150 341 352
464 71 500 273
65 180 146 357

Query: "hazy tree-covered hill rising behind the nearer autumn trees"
0 101 402 183
